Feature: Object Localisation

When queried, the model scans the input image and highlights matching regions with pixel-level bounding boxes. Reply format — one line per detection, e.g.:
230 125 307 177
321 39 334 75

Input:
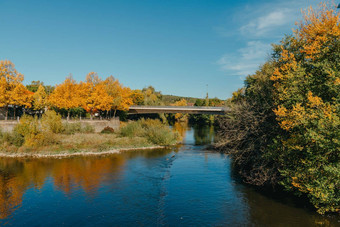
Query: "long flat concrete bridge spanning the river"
129 106 229 115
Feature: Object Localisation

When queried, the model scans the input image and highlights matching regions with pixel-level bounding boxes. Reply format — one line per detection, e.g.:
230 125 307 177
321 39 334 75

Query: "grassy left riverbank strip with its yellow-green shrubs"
0 111 181 154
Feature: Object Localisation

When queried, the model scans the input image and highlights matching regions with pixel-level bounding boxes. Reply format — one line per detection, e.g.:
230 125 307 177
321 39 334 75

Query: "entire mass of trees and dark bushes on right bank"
216 4 340 214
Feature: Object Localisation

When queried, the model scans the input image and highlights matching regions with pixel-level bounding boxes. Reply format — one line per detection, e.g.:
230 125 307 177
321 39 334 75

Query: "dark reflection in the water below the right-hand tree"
241 186 337 226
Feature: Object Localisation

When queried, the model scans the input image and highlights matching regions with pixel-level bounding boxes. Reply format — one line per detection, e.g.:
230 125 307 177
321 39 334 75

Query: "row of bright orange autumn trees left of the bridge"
0 60 144 119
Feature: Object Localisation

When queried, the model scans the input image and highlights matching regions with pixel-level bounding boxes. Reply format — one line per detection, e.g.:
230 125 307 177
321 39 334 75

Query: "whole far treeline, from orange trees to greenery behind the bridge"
0 60 224 120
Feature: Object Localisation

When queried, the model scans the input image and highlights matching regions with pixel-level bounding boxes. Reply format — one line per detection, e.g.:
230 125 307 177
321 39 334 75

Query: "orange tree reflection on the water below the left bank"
0 155 126 219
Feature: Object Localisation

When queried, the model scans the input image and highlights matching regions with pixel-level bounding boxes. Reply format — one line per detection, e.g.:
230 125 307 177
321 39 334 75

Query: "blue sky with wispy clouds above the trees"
0 0 319 99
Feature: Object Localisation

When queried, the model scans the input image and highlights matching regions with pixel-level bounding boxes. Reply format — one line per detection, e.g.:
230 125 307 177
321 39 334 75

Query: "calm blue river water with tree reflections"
0 125 340 226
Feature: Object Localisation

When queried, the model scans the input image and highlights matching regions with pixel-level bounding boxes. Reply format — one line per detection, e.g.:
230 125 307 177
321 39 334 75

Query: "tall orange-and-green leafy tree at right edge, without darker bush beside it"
271 4 340 213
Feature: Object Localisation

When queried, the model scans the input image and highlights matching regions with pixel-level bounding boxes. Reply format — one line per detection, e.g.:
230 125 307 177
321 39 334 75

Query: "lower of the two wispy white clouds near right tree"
217 41 271 76
